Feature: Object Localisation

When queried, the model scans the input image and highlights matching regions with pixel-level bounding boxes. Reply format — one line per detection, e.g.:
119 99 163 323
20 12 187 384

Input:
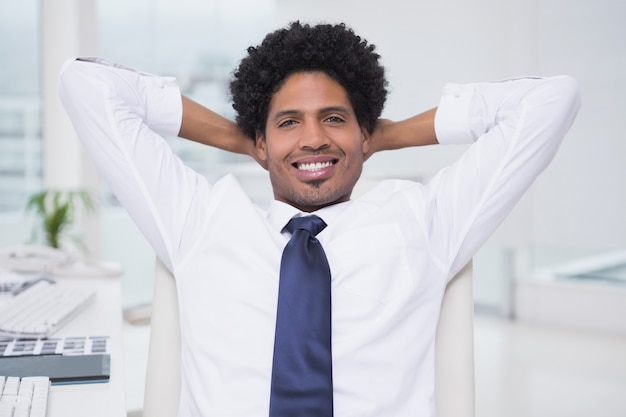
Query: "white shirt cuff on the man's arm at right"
435 84 475 145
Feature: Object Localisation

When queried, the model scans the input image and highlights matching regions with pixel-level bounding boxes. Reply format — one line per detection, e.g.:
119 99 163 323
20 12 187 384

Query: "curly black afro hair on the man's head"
230 21 387 139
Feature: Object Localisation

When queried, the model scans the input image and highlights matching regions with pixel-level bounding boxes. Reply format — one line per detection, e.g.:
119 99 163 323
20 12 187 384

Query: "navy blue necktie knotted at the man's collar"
270 216 333 417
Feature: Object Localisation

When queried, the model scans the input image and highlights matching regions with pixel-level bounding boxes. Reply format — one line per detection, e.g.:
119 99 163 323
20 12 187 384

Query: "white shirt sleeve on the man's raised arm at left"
59 58 203 267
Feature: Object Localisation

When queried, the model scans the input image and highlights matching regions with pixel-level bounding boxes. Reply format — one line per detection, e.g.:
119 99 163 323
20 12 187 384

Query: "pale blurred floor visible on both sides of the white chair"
124 315 626 417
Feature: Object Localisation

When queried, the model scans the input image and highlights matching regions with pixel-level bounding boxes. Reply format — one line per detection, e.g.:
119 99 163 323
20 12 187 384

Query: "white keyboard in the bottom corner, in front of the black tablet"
0 375 50 417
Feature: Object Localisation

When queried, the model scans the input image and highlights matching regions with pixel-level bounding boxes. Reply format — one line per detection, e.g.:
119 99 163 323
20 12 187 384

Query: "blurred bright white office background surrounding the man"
0 0 626 417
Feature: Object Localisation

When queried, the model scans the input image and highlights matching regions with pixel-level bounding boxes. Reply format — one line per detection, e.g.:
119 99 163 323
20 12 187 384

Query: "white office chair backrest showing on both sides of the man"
143 261 474 417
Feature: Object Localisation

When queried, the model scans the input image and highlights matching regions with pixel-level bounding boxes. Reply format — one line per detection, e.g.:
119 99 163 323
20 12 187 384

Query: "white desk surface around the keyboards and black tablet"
0 277 126 417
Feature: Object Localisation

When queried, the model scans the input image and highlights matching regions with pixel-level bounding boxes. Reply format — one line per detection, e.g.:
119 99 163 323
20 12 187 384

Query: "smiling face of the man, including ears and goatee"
256 72 369 212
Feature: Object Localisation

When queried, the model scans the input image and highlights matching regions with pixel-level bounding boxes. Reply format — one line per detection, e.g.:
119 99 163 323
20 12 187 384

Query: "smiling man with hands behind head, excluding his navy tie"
61 22 579 416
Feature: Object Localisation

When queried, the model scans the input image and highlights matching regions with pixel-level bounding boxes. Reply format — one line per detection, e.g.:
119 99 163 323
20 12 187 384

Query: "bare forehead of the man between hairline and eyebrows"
269 71 352 114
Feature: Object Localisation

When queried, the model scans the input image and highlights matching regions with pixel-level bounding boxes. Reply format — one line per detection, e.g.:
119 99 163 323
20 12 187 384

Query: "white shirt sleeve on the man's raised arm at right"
427 76 580 277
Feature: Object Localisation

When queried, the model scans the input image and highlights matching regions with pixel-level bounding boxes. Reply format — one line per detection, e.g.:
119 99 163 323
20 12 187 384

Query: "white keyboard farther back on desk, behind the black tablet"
0 280 95 339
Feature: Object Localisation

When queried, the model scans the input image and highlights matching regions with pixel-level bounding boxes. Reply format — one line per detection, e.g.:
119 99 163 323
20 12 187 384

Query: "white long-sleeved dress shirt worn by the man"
60 59 579 417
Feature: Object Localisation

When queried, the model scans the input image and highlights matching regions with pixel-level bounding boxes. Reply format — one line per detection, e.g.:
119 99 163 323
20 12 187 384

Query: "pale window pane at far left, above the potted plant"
0 0 42 212
